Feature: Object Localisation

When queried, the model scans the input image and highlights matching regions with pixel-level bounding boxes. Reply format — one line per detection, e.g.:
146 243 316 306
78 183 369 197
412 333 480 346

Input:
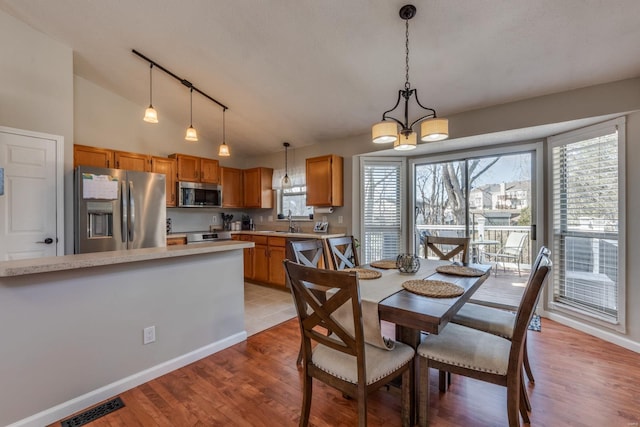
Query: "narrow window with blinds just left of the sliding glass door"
361 159 404 263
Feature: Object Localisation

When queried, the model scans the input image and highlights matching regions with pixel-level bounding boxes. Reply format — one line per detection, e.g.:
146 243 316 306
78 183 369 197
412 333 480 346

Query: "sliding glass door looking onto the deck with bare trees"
413 151 535 264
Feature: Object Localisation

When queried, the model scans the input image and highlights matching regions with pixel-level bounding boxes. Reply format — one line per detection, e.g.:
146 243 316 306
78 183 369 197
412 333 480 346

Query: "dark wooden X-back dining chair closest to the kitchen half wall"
284 260 415 427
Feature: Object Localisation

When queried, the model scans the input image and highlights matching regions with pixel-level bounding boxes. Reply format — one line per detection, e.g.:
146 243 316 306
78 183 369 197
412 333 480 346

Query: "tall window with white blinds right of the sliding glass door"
550 118 625 330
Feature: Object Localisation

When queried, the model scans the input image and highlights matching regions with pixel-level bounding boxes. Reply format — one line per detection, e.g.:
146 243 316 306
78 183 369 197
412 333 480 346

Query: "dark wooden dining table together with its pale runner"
360 259 491 425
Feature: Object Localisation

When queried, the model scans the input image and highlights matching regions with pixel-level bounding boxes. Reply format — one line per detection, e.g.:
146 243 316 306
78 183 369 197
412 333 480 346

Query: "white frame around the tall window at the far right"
546 116 627 333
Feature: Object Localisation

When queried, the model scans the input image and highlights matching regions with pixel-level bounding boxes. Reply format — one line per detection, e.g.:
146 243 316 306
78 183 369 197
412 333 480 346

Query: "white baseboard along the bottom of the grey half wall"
8 331 247 427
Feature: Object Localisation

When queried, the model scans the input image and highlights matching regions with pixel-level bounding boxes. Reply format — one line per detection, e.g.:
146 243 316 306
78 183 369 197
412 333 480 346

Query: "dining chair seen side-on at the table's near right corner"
416 248 551 427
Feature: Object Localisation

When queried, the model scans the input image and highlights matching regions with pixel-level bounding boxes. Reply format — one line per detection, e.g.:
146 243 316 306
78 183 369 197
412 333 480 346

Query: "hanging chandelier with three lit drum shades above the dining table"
371 4 449 150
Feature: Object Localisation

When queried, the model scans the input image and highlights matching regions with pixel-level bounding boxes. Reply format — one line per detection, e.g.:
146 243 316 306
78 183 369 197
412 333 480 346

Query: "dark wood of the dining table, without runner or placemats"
378 260 491 425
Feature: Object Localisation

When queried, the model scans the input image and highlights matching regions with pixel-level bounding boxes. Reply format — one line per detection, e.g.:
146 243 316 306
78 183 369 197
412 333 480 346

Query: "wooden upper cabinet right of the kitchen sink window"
306 154 344 207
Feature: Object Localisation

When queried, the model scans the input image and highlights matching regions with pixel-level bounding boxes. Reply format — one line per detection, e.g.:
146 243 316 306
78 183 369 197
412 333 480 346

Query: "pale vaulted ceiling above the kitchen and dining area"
0 0 640 155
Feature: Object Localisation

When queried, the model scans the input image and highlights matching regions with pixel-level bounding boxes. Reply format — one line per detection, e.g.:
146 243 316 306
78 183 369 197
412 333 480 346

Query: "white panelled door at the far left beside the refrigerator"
0 128 62 261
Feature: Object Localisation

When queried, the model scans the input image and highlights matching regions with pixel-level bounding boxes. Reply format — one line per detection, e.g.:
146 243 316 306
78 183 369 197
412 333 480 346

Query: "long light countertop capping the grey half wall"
0 241 254 277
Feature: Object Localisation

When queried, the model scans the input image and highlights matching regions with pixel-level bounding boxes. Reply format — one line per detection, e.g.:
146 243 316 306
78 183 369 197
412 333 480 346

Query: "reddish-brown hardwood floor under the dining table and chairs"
51 319 640 427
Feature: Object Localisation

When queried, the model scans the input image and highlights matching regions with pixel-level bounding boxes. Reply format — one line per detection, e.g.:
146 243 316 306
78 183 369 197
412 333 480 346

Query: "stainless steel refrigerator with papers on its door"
74 166 167 254
